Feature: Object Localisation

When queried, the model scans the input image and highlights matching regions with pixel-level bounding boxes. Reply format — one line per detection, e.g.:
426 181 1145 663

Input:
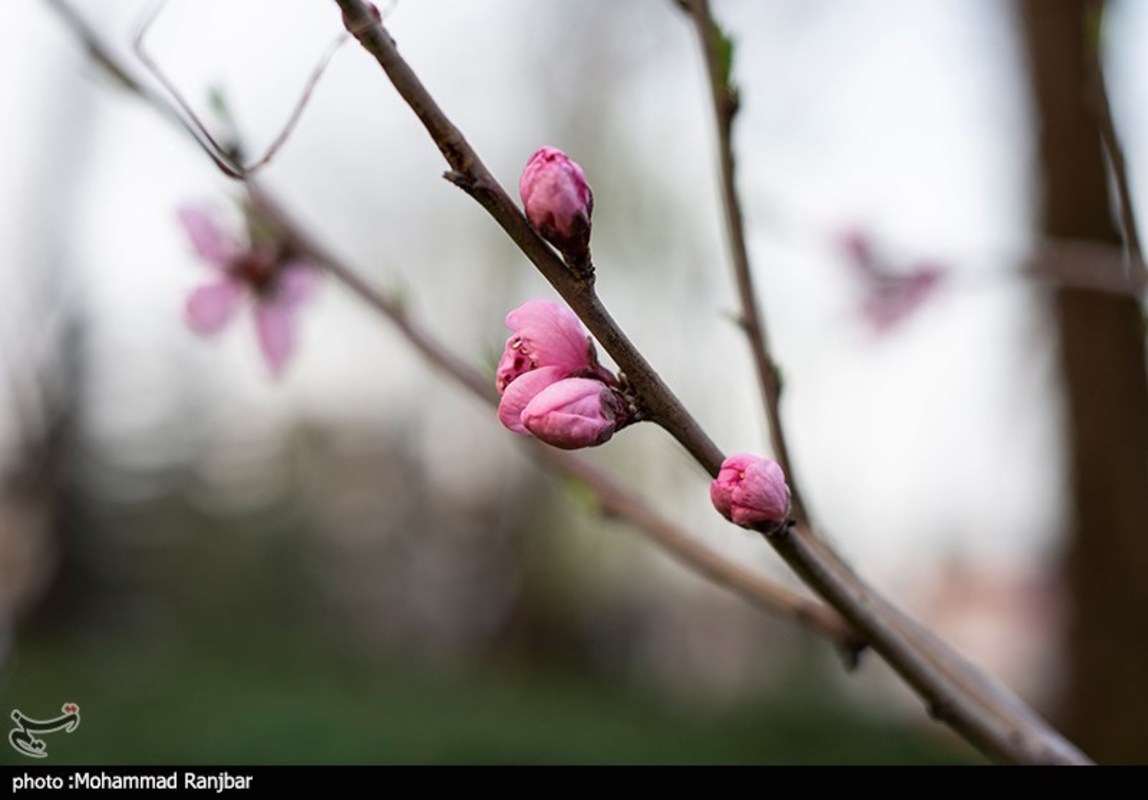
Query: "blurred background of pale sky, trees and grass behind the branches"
0 0 1148 763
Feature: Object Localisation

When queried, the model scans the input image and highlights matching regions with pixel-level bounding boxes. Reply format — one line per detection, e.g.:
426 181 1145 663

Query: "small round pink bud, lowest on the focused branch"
709 453 789 528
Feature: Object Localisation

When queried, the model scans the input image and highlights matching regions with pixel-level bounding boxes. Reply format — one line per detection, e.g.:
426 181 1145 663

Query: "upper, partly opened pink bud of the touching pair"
497 300 600 394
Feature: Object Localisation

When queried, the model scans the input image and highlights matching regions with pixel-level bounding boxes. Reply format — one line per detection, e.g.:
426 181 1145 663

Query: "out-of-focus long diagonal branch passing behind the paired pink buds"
40 0 864 651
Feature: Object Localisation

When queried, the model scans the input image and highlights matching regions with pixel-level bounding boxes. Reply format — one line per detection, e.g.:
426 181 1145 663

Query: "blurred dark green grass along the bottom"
0 640 975 764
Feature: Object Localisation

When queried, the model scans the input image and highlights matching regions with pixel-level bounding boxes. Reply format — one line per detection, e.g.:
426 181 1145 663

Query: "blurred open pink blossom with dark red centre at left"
179 207 317 378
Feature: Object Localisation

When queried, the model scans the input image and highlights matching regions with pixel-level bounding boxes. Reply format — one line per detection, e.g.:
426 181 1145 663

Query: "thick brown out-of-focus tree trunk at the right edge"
1022 0 1148 763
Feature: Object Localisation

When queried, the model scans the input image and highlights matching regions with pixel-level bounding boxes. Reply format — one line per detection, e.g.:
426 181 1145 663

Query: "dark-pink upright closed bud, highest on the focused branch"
518 147 594 261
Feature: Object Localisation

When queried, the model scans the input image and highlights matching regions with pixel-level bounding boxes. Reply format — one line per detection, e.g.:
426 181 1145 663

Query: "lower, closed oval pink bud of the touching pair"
521 378 621 450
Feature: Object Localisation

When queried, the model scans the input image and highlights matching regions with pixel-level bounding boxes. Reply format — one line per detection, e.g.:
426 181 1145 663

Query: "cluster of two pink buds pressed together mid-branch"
496 300 626 450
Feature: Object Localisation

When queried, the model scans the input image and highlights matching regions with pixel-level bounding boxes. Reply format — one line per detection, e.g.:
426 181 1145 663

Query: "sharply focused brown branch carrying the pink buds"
335 0 1088 763
